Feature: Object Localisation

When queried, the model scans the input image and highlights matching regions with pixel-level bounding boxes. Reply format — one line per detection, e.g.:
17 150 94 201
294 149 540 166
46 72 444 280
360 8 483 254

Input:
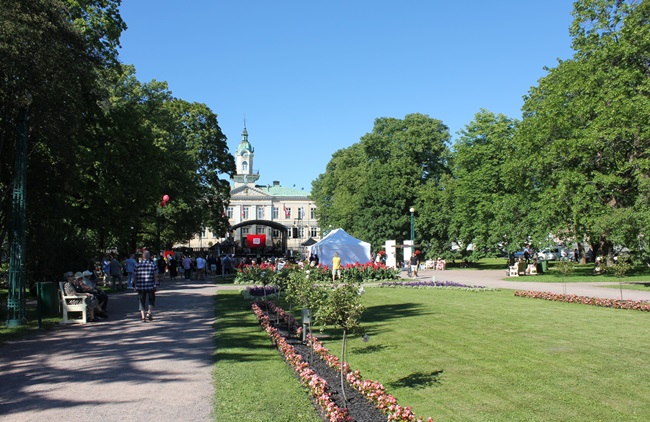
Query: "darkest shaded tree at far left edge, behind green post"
0 0 125 274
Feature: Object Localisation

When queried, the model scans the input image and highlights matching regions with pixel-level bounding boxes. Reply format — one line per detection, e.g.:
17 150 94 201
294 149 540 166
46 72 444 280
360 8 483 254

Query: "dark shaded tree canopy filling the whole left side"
0 0 235 280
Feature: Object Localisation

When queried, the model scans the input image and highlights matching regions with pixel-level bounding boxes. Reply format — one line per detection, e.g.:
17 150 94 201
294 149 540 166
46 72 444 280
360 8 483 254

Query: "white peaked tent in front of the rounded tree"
309 229 370 266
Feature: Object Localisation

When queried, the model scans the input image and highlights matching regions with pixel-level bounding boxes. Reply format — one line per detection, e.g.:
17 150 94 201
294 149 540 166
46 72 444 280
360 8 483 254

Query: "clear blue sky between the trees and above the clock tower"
120 0 572 191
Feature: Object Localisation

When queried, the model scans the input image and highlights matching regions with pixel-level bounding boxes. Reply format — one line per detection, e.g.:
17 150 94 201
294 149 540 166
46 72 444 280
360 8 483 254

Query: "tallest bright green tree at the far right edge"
517 0 650 260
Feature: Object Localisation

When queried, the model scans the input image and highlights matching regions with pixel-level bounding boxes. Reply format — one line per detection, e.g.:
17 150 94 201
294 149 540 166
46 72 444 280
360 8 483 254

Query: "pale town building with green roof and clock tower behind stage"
182 128 321 256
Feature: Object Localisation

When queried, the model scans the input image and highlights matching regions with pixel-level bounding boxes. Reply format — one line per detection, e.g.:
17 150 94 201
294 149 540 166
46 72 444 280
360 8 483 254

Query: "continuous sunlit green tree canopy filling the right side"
313 0 650 260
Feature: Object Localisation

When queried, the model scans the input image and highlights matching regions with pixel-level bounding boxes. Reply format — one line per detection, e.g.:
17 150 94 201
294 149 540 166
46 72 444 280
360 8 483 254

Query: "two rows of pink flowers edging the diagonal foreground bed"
253 302 433 422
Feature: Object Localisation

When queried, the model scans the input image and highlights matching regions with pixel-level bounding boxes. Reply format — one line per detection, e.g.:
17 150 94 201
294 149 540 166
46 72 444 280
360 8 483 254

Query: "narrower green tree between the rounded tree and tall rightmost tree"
438 110 525 260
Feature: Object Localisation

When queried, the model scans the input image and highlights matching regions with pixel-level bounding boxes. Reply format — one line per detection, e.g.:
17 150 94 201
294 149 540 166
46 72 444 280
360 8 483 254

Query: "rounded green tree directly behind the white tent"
312 113 450 249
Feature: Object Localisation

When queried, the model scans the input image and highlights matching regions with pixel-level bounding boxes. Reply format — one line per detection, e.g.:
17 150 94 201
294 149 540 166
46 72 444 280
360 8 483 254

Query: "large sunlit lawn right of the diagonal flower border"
310 288 650 421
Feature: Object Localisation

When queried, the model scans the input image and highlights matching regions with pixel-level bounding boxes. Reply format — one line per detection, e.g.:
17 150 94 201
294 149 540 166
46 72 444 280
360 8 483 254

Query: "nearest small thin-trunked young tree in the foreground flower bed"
315 280 365 402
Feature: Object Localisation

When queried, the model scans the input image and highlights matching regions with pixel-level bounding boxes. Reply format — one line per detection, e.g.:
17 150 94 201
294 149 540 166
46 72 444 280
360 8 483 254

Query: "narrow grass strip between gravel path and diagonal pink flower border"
214 290 321 422
